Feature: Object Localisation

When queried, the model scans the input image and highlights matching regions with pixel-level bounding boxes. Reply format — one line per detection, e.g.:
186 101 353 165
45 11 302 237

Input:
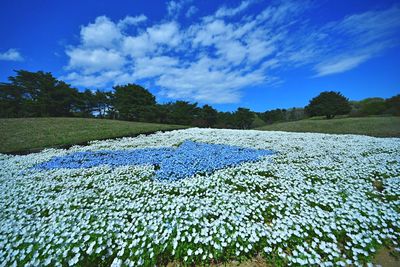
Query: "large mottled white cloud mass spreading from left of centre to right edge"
64 1 400 103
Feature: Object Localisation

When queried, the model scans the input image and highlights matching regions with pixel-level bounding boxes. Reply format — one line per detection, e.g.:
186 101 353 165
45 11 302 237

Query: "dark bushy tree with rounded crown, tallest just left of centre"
113 84 156 121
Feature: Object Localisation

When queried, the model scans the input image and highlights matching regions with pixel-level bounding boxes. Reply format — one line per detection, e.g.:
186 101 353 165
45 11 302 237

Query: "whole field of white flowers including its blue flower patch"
0 128 400 266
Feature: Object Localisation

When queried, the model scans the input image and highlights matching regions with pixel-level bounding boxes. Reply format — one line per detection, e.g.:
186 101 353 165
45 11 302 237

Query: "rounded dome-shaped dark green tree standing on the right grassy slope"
305 91 351 119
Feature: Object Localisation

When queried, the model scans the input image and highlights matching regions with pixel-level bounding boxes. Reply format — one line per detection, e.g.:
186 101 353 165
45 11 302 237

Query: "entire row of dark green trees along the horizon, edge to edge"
0 70 400 129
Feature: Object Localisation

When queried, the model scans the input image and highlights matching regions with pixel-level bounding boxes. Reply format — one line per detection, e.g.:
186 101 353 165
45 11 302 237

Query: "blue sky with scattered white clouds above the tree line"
0 0 400 111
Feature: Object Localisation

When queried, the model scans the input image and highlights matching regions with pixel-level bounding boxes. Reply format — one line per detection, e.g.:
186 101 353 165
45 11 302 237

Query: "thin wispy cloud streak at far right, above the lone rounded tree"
308 6 400 77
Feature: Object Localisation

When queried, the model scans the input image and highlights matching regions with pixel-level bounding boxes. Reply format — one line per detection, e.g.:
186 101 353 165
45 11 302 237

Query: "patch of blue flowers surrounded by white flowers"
35 141 273 181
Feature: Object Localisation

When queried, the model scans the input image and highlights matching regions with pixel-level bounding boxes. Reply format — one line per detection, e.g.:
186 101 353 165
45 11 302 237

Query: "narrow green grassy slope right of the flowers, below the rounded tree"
257 117 400 137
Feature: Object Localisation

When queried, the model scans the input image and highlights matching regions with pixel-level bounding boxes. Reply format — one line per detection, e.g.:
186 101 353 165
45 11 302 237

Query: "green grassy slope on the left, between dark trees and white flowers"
0 118 185 153
